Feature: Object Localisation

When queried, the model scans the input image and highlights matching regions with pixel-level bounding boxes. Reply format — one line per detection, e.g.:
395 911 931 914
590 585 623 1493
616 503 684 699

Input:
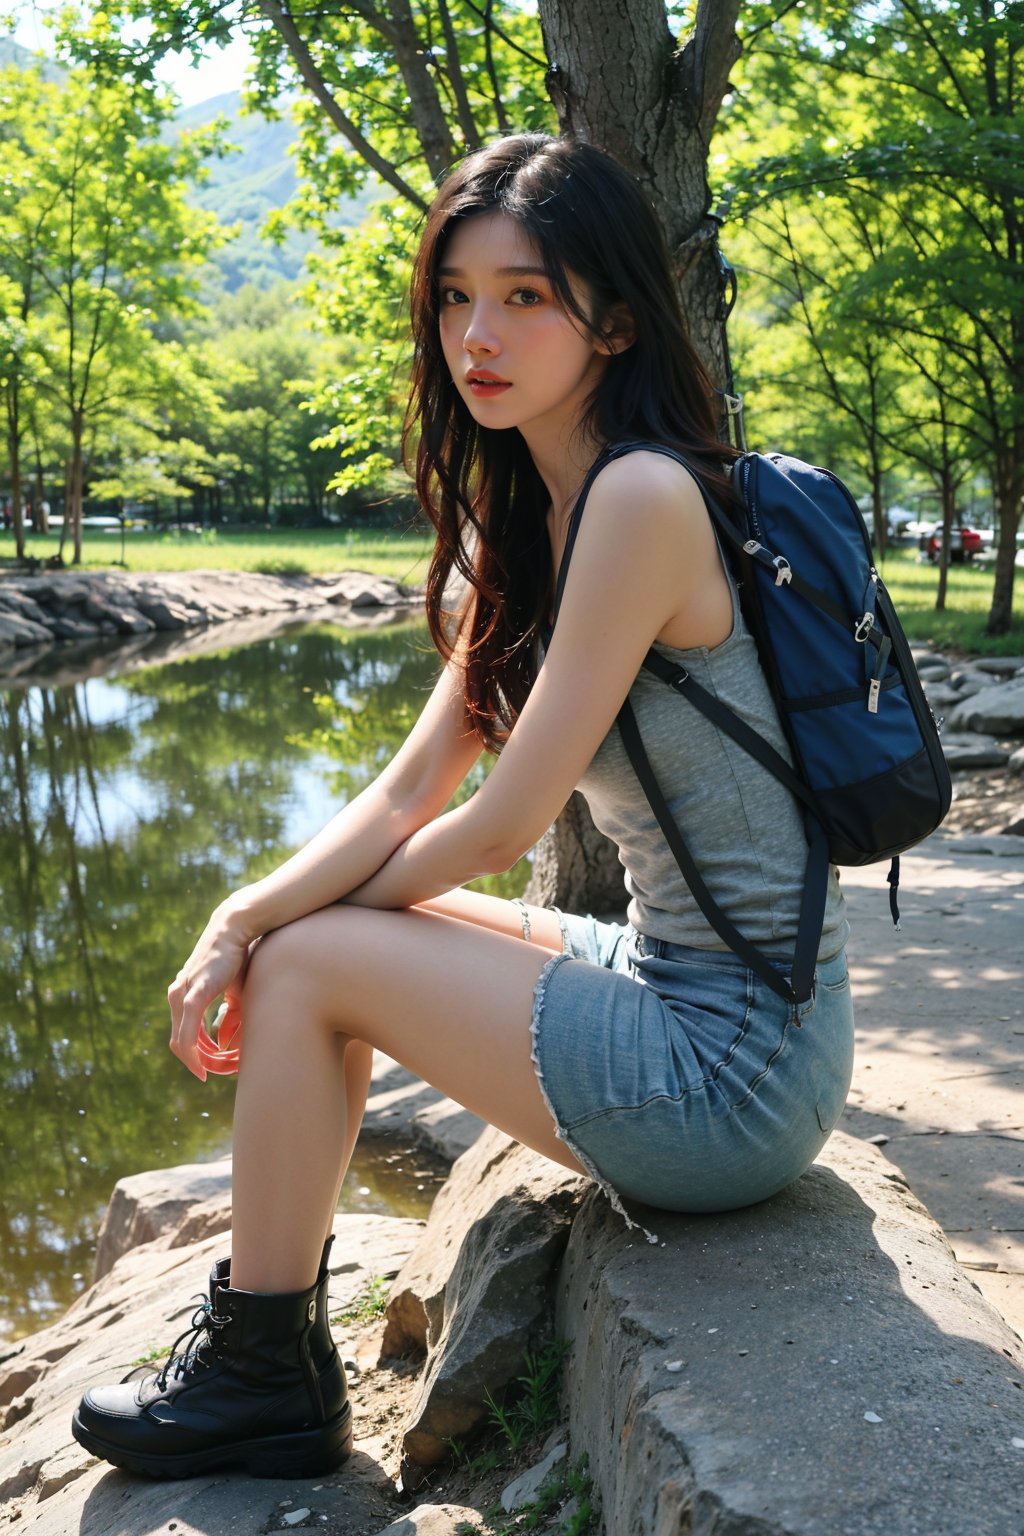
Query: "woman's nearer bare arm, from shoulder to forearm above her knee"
347 453 731 906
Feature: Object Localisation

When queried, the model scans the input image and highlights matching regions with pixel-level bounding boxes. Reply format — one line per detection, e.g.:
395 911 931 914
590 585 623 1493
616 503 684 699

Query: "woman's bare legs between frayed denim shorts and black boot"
232 892 582 1292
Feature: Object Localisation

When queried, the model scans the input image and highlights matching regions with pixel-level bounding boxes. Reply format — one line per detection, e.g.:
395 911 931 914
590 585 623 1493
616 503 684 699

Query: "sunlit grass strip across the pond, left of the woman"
15 528 433 585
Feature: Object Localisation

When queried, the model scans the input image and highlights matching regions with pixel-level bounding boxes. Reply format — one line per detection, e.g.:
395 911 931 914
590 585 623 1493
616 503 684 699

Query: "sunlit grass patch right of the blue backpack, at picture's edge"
880 548 1024 656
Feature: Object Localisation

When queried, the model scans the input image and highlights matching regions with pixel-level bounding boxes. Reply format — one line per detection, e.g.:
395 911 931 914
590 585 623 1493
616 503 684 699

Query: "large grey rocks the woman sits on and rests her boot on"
0 1130 1024 1536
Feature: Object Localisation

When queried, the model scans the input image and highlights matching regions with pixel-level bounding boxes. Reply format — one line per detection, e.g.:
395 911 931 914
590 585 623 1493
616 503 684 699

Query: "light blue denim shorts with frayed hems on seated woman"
531 912 854 1236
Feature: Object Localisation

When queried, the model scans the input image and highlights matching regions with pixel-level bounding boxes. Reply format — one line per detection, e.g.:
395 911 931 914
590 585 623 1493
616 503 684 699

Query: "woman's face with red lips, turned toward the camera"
438 214 608 447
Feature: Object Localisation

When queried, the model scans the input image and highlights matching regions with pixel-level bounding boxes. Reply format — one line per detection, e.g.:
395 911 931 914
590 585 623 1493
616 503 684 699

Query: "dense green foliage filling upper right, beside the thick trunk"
717 0 1024 622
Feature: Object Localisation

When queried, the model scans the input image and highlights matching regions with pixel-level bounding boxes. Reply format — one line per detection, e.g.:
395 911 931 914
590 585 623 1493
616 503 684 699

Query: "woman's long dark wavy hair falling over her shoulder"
405 134 734 748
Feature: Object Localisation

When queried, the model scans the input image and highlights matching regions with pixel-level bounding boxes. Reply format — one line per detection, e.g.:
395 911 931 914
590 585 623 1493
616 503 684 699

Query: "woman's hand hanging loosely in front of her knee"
167 903 253 1083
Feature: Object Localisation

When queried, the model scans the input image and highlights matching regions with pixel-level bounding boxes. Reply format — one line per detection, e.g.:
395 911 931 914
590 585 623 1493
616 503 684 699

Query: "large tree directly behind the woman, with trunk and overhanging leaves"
57 0 740 905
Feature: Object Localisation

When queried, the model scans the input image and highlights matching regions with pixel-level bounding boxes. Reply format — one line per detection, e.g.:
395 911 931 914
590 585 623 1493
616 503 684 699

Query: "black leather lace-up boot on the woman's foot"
71 1240 352 1478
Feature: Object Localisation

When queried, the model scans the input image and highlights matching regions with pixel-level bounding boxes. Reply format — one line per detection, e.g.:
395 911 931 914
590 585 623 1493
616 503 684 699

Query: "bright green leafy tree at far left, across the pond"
0 71 225 561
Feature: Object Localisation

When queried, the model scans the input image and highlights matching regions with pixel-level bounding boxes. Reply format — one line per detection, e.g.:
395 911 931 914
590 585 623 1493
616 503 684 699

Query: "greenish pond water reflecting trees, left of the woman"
0 624 525 1342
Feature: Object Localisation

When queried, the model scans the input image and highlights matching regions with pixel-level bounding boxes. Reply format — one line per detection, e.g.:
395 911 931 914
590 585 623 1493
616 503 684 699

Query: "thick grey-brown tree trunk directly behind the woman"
527 0 740 912
